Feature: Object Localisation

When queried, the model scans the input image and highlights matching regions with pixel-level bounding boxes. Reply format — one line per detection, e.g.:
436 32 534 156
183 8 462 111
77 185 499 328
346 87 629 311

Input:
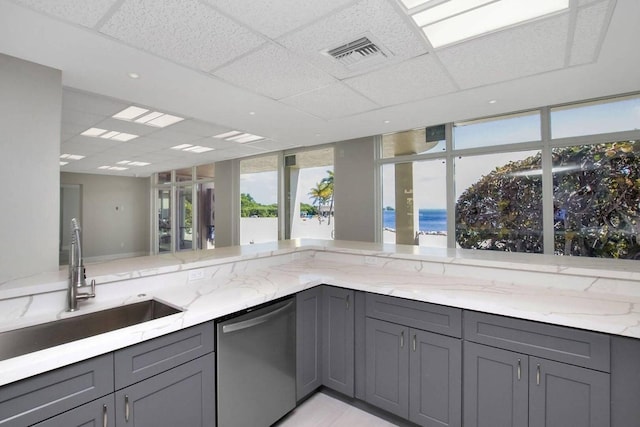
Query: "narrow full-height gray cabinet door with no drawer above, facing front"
322 286 355 397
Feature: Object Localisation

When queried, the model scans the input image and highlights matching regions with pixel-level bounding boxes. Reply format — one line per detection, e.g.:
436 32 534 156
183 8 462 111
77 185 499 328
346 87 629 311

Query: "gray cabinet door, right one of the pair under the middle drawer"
409 329 462 427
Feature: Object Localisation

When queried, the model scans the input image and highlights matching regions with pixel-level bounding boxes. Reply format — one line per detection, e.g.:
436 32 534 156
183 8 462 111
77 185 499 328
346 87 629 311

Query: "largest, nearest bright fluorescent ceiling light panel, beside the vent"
413 0 569 48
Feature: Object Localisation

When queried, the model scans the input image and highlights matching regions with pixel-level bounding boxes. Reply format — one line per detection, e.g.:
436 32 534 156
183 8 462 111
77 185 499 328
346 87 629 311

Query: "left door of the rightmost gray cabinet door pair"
463 342 528 427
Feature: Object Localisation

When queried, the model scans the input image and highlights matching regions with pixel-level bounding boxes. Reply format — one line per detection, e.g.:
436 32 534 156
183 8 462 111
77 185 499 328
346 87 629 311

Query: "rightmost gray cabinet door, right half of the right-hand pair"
529 357 608 427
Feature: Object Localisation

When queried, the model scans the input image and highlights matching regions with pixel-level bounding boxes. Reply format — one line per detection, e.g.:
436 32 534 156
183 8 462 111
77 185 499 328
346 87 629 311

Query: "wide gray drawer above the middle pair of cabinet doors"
366 293 462 338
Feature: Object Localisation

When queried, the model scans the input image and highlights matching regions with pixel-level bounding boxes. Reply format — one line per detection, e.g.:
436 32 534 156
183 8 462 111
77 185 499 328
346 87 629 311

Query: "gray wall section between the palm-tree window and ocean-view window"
334 137 380 242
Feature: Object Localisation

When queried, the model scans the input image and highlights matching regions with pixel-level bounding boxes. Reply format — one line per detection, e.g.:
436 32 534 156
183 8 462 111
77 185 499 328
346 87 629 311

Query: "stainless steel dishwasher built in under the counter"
216 298 296 427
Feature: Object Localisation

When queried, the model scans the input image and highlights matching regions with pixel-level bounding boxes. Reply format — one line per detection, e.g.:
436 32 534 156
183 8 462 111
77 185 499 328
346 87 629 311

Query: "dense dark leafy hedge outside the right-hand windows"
456 141 640 259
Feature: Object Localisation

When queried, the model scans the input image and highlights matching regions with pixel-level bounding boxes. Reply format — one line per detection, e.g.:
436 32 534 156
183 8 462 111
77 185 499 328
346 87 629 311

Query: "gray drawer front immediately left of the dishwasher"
115 322 214 390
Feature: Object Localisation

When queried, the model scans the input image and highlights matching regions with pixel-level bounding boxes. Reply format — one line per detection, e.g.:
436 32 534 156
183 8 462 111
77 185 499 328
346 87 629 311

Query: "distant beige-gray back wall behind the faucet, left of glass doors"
60 172 151 261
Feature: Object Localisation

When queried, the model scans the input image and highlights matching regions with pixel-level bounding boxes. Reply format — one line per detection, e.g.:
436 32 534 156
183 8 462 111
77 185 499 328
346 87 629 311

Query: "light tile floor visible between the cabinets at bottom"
275 392 397 427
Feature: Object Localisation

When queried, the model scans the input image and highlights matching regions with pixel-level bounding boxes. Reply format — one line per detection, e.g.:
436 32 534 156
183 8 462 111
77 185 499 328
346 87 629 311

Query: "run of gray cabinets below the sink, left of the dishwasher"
0 322 215 427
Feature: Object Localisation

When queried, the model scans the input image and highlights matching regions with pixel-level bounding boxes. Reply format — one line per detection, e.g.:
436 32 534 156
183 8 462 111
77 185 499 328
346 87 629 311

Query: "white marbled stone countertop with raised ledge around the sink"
0 241 640 385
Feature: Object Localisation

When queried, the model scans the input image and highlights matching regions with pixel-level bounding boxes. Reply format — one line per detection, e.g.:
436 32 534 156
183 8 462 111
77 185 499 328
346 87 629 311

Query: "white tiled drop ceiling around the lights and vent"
0 0 640 176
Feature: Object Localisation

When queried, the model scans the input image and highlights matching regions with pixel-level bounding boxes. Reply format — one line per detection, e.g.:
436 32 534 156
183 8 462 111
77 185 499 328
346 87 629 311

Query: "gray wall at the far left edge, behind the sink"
0 54 62 283
